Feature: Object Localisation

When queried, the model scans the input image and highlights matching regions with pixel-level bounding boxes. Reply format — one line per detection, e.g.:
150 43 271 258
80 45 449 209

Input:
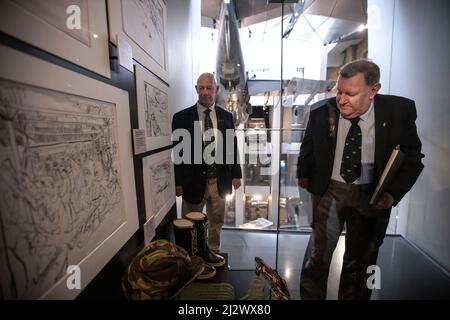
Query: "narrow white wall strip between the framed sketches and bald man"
166 0 201 119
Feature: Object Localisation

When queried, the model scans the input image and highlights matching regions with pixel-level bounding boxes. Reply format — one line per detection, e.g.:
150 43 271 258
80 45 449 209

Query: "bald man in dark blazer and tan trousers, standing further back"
172 73 242 253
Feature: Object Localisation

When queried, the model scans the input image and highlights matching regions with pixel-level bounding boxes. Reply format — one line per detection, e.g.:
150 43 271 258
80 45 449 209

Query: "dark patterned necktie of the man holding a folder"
341 117 362 183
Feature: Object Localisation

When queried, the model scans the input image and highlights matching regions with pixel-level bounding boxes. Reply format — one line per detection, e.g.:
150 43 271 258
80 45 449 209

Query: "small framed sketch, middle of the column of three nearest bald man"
135 65 172 151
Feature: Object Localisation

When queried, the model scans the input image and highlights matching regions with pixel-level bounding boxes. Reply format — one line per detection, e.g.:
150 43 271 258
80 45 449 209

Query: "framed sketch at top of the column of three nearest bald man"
108 0 169 82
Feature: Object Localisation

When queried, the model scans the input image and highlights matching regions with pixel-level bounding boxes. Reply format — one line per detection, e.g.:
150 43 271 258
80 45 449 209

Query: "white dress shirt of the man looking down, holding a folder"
331 101 375 184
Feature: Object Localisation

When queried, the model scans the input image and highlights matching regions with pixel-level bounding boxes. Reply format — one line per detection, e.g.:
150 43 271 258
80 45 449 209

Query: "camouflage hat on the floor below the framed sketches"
122 240 204 300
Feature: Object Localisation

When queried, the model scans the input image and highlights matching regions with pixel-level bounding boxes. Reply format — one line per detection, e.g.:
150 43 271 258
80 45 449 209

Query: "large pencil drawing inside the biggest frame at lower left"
0 81 124 299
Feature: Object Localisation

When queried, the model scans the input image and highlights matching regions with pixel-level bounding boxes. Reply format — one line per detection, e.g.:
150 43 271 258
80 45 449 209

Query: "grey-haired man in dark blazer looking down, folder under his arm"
297 60 423 299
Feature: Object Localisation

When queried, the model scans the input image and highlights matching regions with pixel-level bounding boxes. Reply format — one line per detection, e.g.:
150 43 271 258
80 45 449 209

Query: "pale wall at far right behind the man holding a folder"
368 0 450 272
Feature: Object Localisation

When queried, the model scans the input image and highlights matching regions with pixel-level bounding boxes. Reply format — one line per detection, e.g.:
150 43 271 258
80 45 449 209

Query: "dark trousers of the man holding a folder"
300 180 390 300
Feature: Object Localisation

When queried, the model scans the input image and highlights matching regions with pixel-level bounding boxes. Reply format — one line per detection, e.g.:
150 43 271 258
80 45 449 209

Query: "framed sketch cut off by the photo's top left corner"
0 0 111 78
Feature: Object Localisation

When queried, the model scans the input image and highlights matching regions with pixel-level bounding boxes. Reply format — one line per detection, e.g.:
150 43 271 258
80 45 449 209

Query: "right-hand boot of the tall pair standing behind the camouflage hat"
186 212 225 267
